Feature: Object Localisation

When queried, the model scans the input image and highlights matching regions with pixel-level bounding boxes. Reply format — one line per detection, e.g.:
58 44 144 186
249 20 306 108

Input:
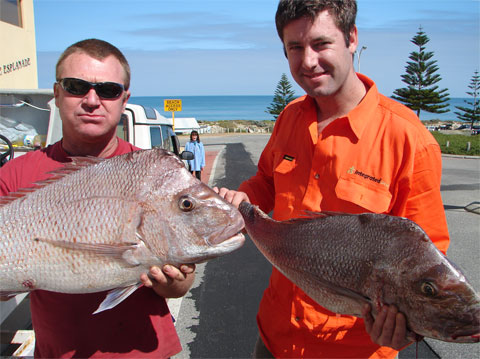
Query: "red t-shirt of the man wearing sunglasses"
0 139 182 358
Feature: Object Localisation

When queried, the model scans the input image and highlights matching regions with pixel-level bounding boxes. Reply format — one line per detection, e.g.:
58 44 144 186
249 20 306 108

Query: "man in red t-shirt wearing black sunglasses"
0 39 195 358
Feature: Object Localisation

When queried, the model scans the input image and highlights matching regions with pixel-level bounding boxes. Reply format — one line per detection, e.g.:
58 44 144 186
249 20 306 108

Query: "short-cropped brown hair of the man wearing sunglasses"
55 39 130 90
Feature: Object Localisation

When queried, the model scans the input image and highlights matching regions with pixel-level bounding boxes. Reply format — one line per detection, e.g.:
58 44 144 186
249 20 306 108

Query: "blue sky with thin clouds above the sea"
34 0 480 97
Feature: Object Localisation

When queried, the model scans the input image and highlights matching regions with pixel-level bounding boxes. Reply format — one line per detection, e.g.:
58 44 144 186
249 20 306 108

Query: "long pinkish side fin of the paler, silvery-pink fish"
35 238 145 266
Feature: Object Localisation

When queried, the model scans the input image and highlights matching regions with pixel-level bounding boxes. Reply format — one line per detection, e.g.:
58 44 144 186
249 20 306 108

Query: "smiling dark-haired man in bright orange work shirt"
219 0 449 358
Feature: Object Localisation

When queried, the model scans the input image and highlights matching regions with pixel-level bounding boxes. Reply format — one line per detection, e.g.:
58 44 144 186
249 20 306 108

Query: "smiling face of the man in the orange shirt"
283 11 357 97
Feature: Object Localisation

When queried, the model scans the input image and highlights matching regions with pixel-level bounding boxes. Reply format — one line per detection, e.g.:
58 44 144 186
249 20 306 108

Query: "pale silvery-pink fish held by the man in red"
0 149 244 312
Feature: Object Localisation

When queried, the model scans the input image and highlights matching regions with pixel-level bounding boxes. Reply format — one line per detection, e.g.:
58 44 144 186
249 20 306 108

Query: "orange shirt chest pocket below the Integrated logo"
335 178 392 213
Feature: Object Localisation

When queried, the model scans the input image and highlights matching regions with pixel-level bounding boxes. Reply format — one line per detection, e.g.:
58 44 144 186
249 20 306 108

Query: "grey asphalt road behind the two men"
174 135 480 359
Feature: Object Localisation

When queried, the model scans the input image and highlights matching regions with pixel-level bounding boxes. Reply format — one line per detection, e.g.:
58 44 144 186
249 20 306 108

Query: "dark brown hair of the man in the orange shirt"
275 0 357 47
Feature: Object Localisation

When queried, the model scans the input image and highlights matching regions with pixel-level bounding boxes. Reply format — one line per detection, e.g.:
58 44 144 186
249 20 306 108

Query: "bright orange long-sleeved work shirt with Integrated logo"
239 74 449 358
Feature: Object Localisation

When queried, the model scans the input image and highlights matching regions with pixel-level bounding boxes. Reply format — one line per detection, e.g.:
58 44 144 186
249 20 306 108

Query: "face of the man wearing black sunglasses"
54 52 130 143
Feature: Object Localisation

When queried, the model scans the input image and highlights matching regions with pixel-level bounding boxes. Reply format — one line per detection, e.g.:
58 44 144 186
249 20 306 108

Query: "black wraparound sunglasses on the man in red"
58 77 125 99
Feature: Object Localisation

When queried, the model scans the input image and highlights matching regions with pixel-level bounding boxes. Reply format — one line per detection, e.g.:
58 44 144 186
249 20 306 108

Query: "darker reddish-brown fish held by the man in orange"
239 202 480 343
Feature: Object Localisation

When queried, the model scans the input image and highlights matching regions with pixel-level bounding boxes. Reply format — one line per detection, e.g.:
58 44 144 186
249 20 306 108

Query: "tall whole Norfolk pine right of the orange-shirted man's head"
392 27 450 117
